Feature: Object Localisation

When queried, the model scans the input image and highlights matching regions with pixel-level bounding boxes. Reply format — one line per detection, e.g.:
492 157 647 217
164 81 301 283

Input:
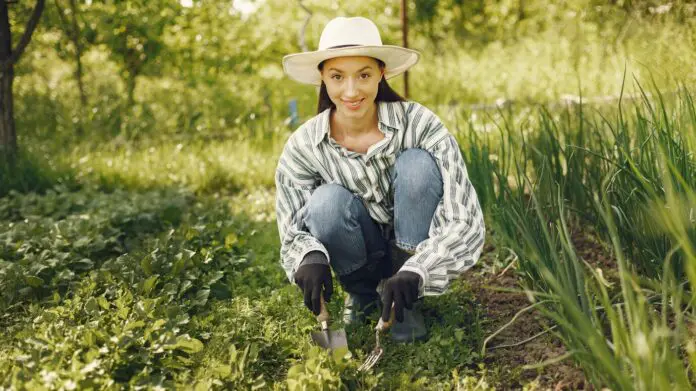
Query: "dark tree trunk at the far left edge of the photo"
0 0 17 162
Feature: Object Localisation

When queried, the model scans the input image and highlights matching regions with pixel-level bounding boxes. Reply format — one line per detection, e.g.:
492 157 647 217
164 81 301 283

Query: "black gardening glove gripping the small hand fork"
382 271 421 322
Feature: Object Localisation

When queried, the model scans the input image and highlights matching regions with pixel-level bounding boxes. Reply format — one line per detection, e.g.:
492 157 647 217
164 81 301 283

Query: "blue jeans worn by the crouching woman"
304 148 443 294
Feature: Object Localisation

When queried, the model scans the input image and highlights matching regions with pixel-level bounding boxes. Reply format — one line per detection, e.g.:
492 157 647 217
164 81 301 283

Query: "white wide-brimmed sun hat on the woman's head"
283 17 420 86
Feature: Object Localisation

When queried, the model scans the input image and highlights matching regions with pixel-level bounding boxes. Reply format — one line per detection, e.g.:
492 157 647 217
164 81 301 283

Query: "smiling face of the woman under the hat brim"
321 57 383 118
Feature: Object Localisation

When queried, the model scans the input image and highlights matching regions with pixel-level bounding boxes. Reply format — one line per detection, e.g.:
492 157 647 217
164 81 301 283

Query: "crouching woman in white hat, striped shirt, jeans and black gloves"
275 17 485 341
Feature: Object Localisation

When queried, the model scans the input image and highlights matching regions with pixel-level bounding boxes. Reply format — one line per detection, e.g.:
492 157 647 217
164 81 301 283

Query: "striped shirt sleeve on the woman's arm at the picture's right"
400 110 486 296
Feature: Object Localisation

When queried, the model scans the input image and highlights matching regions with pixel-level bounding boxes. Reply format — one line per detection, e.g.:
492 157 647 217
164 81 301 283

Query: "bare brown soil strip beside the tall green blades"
466 228 616 390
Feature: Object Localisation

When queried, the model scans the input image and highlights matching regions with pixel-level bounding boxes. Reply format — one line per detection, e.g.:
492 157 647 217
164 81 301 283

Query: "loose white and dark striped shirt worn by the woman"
275 102 485 296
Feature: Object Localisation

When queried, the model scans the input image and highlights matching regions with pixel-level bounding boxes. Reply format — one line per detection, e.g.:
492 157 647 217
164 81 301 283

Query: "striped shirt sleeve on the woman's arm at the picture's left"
275 138 329 283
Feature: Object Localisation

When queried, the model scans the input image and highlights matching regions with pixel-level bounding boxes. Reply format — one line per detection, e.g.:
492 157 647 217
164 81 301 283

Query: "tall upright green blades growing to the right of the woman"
464 85 696 390
